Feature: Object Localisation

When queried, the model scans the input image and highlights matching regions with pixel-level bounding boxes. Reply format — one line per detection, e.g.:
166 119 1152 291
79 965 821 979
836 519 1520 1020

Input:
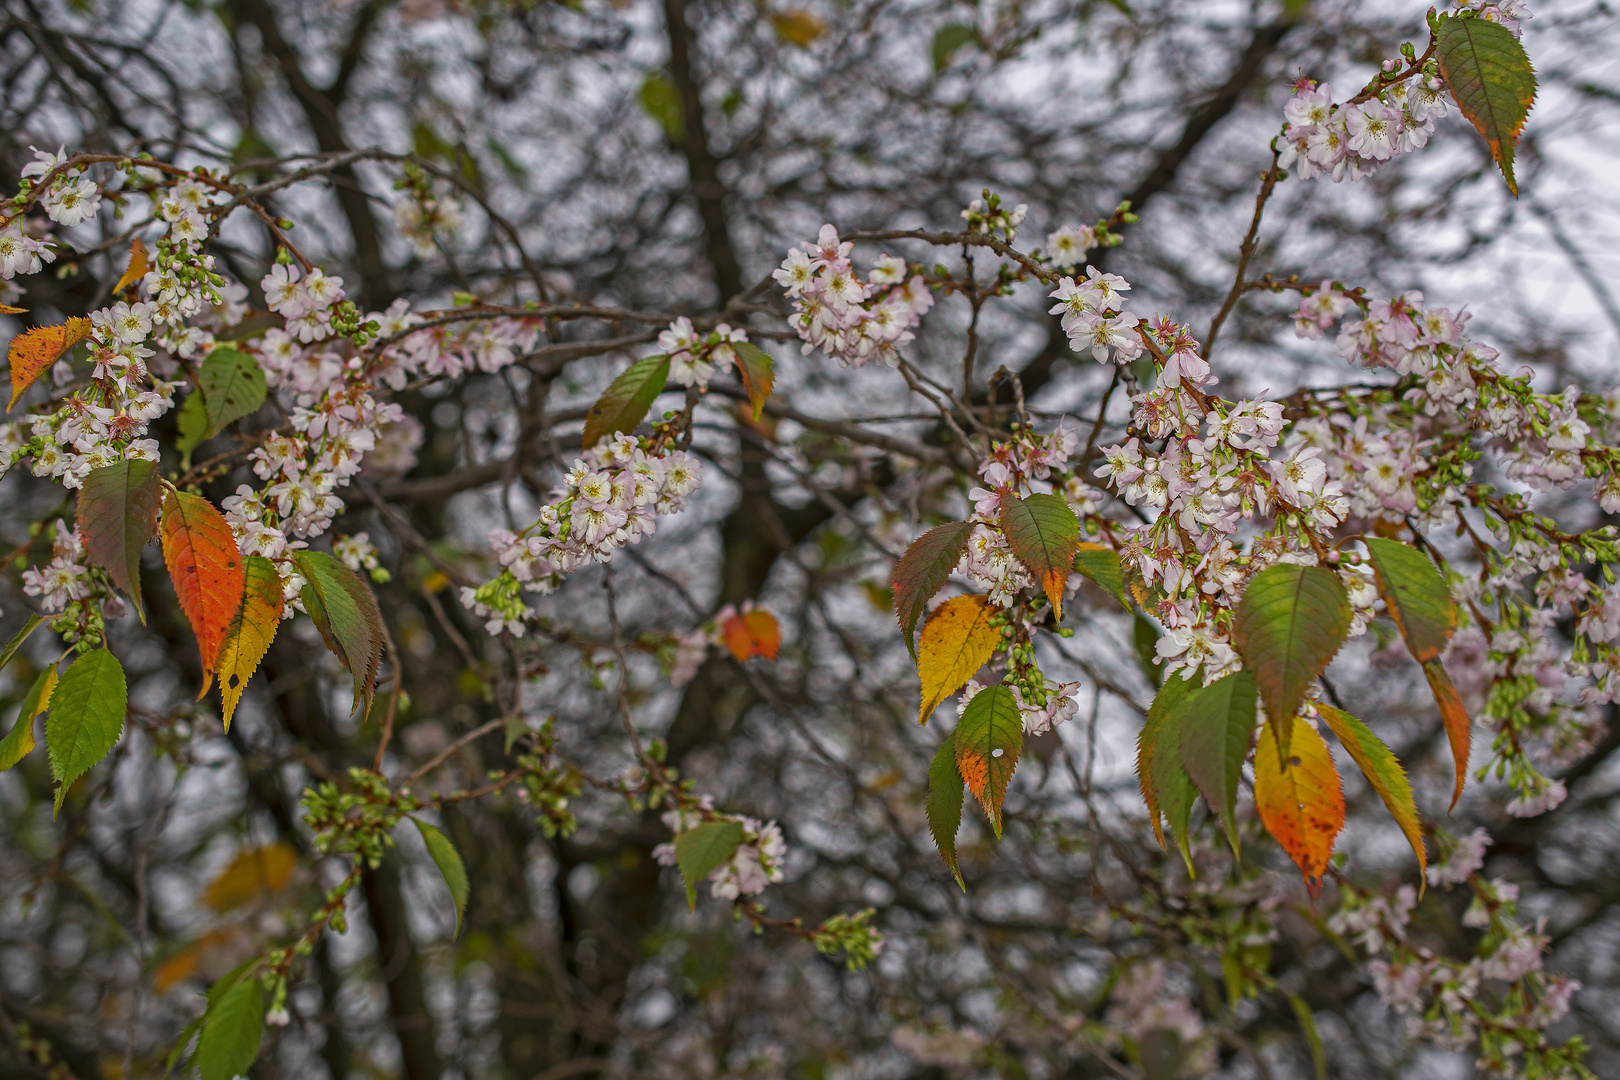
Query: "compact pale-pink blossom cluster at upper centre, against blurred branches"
773 225 933 368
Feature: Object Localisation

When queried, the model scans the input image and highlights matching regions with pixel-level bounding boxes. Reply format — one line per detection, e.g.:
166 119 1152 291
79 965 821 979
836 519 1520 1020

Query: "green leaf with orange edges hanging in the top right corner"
1435 15 1536 198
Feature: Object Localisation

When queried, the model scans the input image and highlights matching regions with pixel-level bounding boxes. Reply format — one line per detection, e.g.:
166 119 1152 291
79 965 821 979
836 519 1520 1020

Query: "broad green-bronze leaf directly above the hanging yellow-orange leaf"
1231 562 1349 738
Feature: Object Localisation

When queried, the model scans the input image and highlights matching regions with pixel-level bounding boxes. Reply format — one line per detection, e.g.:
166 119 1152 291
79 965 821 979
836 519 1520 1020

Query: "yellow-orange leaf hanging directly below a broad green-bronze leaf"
1254 716 1345 900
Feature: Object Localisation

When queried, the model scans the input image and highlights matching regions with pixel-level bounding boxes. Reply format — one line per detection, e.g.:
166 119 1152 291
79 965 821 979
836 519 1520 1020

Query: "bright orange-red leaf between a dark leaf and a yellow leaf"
162 489 248 678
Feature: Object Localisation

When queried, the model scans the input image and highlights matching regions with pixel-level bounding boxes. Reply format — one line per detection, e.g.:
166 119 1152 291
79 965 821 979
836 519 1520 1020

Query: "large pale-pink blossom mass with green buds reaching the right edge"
1290 282 1620 816
